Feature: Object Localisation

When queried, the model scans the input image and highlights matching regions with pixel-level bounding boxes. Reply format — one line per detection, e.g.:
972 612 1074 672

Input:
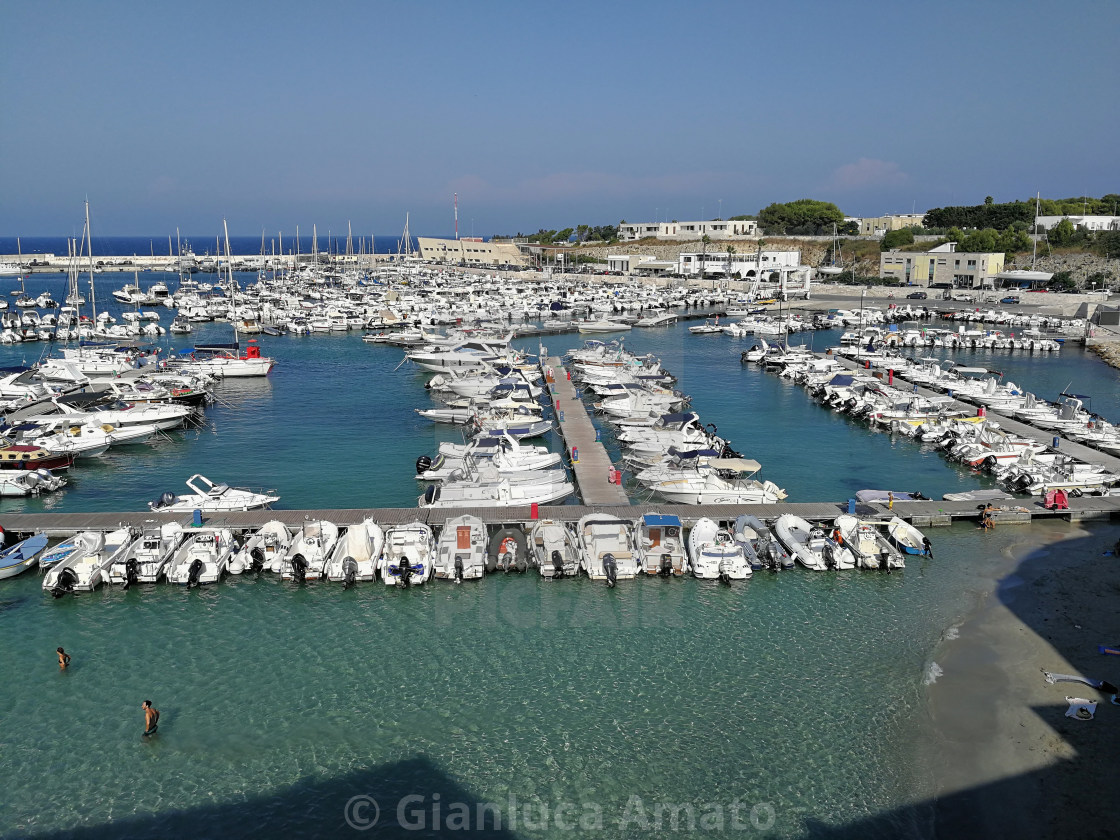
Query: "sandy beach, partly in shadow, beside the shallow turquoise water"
917 523 1120 838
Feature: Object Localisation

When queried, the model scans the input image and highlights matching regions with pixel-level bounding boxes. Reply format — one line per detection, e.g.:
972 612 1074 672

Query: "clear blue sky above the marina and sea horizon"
0 0 1120 235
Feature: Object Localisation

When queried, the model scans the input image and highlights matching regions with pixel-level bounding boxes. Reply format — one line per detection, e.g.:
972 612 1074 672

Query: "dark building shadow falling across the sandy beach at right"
804 526 1120 840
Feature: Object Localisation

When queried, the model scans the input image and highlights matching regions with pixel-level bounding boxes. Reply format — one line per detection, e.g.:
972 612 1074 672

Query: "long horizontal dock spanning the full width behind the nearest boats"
0 496 1120 536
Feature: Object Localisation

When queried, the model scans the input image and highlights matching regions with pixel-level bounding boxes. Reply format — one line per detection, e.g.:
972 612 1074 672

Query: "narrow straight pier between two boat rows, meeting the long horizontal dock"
541 354 629 505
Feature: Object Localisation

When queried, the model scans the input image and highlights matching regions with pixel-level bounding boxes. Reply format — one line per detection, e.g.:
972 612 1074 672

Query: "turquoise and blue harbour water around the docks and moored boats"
0 276 1114 838
